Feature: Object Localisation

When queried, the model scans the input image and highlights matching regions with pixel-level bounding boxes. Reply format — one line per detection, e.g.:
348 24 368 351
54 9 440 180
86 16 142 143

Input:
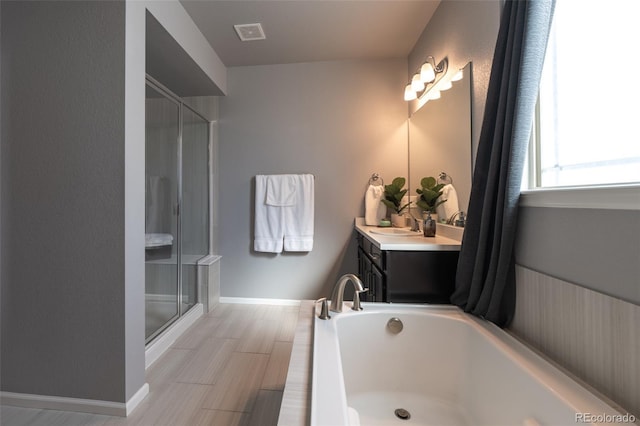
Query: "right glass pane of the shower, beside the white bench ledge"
180 105 209 313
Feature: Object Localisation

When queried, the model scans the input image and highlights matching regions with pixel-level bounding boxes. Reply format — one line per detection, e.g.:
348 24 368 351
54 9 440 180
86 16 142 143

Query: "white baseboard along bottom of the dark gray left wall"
0 383 149 417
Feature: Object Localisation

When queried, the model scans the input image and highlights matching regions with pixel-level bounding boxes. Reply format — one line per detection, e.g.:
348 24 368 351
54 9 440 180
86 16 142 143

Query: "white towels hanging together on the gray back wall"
253 174 314 253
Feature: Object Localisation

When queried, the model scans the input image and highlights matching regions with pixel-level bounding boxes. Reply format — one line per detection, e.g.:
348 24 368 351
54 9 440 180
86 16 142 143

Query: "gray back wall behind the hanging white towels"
220 60 407 299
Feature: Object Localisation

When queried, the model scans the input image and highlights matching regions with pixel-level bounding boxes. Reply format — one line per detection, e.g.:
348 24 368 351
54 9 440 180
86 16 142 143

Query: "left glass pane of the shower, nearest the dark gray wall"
145 85 180 341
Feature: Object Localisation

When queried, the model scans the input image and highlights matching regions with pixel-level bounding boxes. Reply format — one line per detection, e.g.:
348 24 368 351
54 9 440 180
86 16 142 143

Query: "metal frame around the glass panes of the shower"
145 74 211 345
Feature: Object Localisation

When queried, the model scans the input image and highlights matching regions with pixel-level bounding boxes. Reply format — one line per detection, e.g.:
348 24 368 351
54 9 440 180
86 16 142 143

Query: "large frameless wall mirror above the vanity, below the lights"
408 62 473 219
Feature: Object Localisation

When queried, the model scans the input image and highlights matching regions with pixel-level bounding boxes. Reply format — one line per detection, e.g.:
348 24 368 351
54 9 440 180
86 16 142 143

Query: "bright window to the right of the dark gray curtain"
525 0 640 188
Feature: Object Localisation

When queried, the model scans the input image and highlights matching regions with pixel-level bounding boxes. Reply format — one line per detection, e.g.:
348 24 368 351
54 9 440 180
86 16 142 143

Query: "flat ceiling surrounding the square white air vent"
181 0 440 67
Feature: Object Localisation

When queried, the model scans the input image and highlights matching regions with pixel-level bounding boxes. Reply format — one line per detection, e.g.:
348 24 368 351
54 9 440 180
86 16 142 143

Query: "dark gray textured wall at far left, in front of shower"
1 2 136 402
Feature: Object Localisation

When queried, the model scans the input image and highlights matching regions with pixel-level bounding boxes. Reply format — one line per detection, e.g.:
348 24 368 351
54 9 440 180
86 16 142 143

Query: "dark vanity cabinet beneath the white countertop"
356 232 459 303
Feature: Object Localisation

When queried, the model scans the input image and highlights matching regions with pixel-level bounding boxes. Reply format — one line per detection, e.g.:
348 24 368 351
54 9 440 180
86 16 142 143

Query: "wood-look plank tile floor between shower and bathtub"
0 304 300 426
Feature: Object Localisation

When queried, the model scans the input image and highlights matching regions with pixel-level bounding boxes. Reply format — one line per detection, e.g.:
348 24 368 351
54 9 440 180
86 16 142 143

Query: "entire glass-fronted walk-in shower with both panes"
145 77 210 343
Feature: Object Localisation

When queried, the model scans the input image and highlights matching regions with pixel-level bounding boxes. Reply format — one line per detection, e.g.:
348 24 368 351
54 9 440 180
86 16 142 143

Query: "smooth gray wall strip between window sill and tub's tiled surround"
516 207 640 305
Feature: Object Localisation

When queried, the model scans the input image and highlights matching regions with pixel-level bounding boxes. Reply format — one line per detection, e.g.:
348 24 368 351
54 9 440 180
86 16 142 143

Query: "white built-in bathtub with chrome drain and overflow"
311 303 635 426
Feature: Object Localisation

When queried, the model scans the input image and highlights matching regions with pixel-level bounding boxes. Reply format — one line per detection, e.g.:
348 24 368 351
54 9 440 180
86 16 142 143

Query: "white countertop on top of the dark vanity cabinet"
355 217 463 251
